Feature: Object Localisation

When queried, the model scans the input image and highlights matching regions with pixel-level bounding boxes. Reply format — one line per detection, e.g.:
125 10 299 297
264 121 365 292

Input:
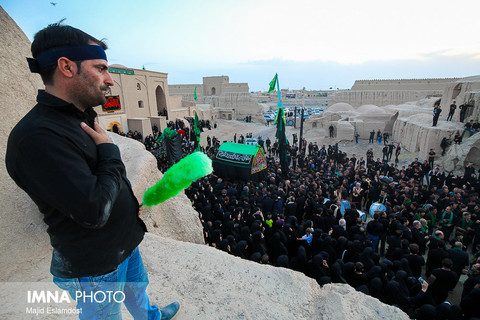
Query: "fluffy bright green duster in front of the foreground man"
143 152 213 207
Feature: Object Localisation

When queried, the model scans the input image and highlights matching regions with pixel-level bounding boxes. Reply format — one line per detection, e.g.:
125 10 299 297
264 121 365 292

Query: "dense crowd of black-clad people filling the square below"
122 121 480 319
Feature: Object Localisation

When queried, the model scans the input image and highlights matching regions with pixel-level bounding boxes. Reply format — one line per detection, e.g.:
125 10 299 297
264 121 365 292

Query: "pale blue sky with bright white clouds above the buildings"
0 0 480 91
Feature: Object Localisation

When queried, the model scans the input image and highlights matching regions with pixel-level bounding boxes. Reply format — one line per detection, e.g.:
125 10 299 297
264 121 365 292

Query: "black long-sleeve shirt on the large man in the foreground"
6 90 146 278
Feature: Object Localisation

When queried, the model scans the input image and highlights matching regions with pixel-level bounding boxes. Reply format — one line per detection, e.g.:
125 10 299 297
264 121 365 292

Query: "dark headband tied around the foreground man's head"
27 45 107 73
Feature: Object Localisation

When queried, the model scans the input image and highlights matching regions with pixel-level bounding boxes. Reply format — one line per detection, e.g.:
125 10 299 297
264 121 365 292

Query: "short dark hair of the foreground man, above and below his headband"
31 21 107 84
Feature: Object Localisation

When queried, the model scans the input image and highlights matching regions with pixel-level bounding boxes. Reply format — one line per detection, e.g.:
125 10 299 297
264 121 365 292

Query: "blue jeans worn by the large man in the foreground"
53 248 161 320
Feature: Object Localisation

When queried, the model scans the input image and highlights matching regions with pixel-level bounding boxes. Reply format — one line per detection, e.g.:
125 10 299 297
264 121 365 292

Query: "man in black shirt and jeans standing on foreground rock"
6 23 179 319
